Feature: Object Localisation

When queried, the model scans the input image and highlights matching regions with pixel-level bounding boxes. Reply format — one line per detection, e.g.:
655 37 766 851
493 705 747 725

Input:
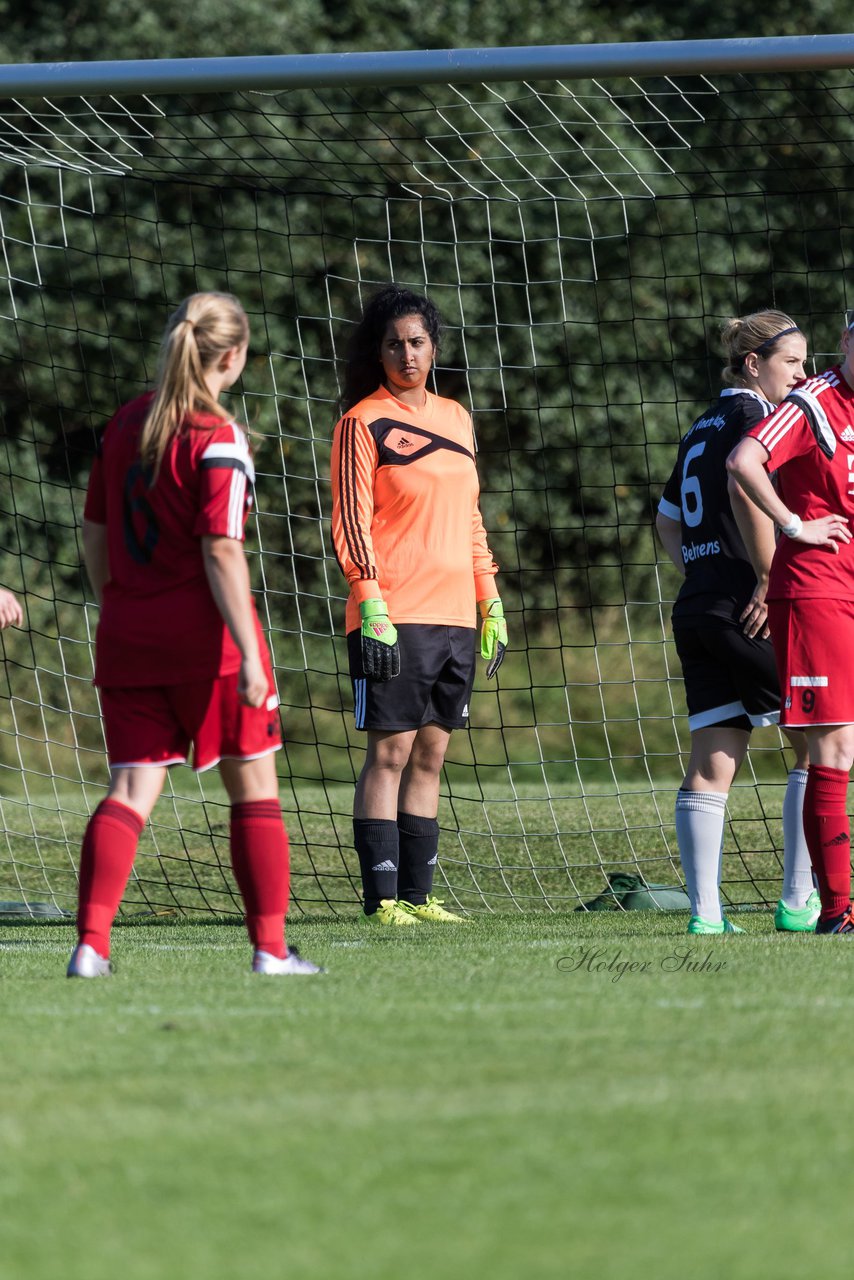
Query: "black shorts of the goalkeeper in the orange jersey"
347 622 478 732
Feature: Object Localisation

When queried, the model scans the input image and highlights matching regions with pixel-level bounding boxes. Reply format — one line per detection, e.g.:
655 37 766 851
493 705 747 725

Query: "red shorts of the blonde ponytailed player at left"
100 663 282 772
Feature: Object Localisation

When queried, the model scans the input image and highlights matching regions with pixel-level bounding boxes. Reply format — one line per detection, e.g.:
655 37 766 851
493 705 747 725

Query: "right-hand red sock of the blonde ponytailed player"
232 800 291 960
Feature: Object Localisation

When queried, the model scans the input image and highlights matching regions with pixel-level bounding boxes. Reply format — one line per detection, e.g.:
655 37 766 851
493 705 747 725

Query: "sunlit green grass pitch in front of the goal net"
0 913 851 1280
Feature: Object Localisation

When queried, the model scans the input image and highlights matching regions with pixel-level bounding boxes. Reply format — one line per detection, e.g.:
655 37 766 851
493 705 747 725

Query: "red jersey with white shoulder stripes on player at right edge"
746 366 854 600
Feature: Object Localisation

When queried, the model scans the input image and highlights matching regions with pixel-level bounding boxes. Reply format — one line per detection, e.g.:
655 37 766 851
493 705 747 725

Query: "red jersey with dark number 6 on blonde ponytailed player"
83 392 264 689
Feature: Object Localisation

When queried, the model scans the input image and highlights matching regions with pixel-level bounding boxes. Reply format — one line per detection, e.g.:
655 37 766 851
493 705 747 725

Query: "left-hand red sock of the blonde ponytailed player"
77 800 145 956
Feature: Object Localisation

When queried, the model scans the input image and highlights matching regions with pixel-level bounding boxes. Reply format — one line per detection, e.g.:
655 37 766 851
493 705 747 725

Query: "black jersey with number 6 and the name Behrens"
658 388 775 621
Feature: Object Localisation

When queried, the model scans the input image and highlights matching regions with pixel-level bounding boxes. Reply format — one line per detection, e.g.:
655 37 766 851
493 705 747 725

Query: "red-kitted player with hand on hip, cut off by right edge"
727 309 854 936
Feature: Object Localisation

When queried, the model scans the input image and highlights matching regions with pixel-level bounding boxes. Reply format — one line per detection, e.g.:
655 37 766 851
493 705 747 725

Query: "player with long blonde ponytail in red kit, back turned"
68 293 319 978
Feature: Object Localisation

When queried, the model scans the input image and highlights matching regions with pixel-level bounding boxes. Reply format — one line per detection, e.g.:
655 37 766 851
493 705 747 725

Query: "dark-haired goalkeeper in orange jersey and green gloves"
332 284 507 925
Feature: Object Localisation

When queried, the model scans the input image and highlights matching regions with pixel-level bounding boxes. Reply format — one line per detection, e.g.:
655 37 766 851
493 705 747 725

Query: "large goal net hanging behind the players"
0 42 854 913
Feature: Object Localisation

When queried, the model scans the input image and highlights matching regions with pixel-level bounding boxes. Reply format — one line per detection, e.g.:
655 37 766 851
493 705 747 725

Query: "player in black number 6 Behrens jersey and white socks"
656 311 819 933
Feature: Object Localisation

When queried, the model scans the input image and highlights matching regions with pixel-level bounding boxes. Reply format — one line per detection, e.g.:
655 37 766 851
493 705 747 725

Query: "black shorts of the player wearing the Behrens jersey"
673 617 780 731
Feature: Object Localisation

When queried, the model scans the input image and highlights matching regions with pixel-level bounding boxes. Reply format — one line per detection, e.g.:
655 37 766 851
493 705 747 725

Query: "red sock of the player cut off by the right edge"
804 764 851 920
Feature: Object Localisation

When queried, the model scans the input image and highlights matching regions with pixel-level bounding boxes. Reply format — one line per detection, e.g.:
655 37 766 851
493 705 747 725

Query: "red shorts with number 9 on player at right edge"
768 600 854 728
